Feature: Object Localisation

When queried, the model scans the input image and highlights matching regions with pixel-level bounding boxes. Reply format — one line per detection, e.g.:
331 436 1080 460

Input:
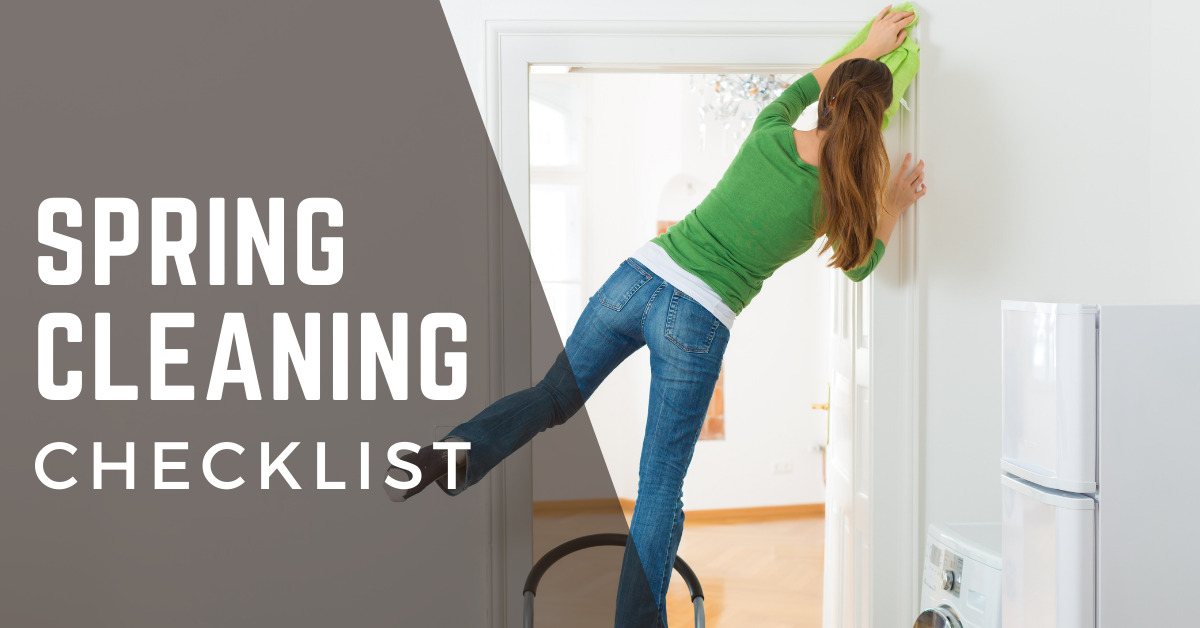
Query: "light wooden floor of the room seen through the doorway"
534 513 824 628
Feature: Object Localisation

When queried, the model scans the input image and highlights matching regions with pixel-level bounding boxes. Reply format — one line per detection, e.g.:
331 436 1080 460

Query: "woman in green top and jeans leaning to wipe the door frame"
389 7 925 627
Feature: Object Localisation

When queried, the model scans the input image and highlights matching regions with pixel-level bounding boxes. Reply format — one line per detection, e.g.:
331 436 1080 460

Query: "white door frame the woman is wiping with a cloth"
485 20 924 627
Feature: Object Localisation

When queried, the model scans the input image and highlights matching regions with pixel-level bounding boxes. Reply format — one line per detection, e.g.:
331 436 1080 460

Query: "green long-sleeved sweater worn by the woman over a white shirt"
653 73 883 313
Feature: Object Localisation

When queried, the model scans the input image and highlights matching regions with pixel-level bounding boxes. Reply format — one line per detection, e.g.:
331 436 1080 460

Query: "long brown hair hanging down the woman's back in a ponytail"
817 59 892 270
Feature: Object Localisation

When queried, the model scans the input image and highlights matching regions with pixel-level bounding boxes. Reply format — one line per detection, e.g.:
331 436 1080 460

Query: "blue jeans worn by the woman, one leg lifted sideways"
442 258 730 628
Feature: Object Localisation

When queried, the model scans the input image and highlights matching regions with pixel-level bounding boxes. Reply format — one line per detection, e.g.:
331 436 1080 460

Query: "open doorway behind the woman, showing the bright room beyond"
528 65 832 628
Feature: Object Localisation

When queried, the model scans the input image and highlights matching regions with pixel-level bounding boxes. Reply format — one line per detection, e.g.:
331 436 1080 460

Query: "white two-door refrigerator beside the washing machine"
1001 301 1200 628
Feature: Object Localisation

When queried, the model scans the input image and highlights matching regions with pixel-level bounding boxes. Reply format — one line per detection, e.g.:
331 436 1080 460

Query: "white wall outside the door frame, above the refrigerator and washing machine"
443 0 1200 535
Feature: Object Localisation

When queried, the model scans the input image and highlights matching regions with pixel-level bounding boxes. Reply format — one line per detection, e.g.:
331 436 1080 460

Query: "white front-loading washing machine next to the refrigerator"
913 524 1002 628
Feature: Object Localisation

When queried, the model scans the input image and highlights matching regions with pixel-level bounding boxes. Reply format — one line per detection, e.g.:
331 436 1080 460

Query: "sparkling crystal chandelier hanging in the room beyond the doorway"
691 74 798 145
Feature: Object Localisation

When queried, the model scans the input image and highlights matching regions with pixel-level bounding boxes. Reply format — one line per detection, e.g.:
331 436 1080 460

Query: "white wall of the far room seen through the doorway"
534 73 829 509
